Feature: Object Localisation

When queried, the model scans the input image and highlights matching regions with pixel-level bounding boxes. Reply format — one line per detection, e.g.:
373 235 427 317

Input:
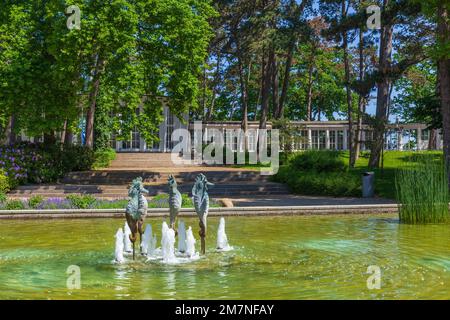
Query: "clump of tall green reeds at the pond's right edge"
395 157 450 224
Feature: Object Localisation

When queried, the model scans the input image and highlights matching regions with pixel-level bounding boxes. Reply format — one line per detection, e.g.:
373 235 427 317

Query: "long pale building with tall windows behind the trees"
106 117 442 152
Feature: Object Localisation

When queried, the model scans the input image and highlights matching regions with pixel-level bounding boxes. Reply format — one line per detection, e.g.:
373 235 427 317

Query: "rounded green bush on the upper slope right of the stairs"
290 150 347 172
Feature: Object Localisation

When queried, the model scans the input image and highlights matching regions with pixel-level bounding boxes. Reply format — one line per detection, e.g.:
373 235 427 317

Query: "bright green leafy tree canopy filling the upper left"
0 0 215 146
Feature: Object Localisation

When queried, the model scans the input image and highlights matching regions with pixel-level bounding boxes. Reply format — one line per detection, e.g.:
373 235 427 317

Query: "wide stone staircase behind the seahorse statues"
9 153 289 199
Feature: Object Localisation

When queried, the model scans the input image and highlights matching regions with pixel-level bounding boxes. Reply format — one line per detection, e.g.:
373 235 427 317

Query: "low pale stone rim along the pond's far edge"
0 204 398 220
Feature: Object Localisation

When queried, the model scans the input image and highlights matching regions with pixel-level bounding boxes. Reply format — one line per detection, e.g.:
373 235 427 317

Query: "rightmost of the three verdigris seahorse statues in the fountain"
192 173 214 254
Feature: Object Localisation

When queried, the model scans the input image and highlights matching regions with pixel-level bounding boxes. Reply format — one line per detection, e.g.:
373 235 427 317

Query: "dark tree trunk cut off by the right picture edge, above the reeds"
438 1 450 188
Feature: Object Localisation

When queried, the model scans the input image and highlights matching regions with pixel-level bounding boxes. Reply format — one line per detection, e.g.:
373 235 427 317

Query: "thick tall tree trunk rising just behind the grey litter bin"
369 0 393 168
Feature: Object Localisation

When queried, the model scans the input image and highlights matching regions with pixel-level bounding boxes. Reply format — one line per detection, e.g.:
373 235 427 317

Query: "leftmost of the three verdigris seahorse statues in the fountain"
125 177 148 260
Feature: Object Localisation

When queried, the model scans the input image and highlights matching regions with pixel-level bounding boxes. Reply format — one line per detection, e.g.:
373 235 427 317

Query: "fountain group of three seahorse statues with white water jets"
116 174 220 264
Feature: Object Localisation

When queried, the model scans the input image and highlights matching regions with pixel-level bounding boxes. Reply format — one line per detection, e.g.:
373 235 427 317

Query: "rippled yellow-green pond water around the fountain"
0 215 450 299
